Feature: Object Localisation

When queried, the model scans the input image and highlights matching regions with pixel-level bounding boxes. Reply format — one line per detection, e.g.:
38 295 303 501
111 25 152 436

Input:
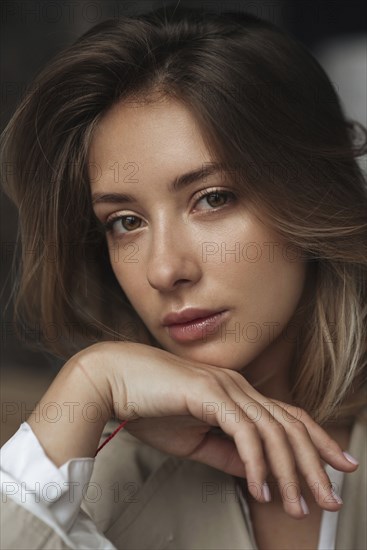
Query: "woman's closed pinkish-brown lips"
166 310 228 342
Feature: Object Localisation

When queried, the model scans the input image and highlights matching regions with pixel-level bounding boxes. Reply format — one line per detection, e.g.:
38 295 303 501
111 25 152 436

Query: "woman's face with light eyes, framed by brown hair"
88 100 306 390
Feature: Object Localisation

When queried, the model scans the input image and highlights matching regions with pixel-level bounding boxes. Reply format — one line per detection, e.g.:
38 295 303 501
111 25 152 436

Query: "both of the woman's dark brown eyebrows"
92 162 222 208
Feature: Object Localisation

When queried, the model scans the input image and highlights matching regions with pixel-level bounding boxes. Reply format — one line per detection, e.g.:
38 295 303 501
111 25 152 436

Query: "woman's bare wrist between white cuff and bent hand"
27 350 113 466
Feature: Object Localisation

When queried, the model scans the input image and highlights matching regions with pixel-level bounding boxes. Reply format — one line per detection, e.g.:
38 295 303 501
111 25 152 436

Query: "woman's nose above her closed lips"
147 226 201 292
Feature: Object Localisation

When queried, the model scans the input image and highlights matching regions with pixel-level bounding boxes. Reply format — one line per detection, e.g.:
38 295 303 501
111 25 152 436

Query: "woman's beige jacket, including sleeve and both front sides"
1 414 367 550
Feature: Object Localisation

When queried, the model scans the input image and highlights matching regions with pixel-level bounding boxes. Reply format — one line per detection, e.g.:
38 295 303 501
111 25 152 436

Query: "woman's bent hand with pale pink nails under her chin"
80 342 357 518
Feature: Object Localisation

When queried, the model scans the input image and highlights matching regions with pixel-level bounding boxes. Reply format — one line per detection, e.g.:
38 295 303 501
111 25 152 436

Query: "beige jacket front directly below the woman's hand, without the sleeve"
82 425 254 550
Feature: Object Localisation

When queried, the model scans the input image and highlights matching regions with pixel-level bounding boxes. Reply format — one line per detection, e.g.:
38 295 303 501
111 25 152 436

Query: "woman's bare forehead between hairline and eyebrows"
88 101 212 192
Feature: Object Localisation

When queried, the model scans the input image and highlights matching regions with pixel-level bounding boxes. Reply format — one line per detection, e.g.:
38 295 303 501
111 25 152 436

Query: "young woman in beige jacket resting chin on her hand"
1 5 367 550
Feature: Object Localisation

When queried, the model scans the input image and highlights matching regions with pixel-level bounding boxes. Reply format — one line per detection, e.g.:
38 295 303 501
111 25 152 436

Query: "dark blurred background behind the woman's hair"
0 0 367 444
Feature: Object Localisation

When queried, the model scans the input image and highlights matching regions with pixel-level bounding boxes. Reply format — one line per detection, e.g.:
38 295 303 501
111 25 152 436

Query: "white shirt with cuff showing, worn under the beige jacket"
0 422 344 550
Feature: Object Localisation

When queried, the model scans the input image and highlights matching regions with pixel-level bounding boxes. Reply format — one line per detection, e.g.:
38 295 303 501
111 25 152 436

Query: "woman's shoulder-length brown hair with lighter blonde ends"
1 7 367 421
